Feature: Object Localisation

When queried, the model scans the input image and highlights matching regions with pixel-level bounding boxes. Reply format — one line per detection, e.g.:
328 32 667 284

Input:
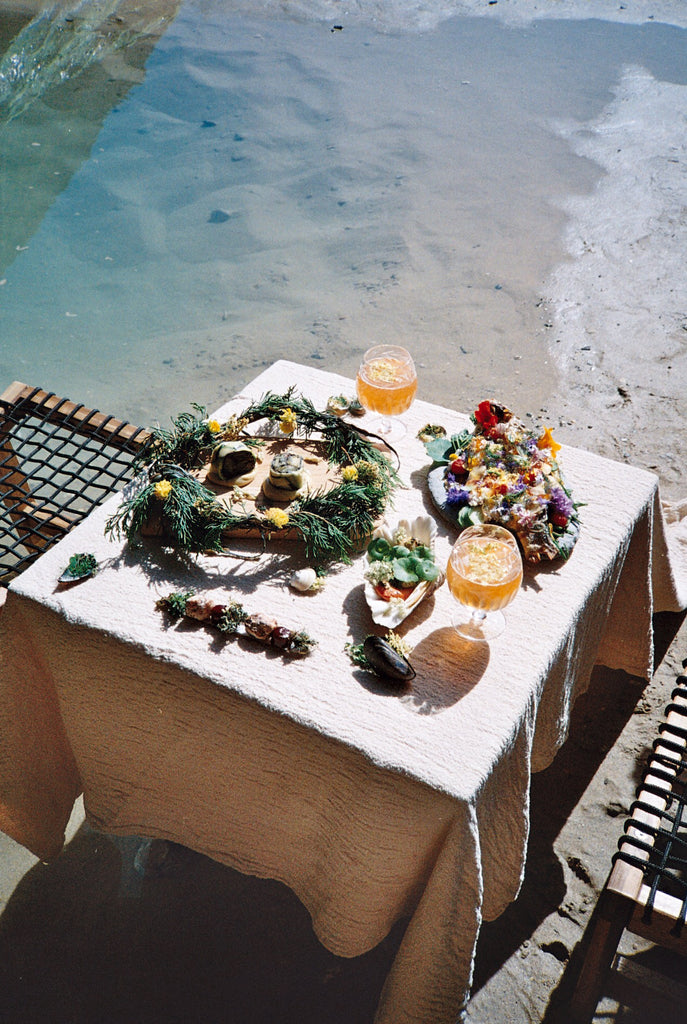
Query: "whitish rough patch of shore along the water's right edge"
547 67 687 391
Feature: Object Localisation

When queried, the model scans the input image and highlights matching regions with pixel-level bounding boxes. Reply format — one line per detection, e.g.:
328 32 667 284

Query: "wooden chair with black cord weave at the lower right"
569 675 687 1024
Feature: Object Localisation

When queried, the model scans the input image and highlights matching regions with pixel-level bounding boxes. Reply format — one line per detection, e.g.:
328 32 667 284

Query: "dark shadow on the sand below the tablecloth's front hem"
0 825 402 1024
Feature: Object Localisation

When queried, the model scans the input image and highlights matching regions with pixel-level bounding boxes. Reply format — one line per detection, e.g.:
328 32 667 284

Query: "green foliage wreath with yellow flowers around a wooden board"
105 388 398 563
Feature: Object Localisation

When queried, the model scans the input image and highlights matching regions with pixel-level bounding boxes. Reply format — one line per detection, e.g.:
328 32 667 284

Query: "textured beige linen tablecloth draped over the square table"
0 361 687 1024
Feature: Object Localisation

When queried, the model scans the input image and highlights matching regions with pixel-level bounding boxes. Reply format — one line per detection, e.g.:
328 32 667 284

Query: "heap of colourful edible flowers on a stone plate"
425 401 579 562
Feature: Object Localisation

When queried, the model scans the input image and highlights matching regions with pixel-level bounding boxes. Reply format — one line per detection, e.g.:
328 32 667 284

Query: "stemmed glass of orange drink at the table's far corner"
355 345 418 441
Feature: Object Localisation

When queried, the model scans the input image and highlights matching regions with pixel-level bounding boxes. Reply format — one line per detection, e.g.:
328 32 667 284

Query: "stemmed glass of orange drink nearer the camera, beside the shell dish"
446 523 522 640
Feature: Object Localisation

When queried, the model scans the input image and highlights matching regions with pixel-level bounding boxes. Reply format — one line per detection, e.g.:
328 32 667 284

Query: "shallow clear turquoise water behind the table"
0 2 685 423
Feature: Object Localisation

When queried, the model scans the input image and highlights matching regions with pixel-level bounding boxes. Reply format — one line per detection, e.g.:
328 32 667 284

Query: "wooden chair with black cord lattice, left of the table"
0 381 149 587
